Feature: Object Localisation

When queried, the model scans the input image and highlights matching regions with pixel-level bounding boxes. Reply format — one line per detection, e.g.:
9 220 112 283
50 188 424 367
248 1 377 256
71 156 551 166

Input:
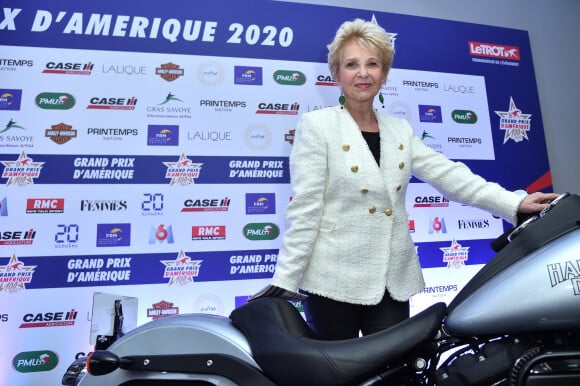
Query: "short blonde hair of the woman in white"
327 19 395 78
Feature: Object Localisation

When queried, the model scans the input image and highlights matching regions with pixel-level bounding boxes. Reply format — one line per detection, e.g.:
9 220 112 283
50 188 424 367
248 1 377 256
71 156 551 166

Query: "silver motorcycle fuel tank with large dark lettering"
445 229 580 336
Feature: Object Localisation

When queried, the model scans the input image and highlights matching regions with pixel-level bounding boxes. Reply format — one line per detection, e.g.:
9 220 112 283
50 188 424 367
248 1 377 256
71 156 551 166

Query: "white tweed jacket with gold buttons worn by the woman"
272 106 523 305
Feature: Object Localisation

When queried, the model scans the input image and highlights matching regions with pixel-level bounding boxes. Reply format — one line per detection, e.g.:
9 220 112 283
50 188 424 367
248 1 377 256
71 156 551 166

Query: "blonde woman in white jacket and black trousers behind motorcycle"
264 19 557 339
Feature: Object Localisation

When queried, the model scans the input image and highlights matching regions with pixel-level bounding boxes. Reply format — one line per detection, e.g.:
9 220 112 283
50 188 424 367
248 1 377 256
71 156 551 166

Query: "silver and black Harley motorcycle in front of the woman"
62 193 580 386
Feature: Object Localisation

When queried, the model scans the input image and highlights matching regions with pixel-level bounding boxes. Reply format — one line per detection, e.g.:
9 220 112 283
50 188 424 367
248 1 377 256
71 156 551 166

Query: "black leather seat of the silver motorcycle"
230 297 447 386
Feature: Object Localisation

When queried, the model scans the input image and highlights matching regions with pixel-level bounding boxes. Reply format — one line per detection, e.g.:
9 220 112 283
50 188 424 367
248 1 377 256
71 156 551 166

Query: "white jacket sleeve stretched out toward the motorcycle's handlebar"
411 121 524 224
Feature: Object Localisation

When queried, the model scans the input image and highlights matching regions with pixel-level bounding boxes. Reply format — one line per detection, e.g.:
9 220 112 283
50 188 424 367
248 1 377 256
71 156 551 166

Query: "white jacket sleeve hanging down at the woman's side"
272 114 328 291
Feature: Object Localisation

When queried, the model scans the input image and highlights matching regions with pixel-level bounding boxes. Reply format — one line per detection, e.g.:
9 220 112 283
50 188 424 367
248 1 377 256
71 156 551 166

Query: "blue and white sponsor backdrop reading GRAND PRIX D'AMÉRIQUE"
0 0 551 385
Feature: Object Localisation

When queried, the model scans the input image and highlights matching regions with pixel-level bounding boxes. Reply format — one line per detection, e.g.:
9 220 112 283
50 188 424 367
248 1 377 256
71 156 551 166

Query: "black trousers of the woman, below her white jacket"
302 291 410 340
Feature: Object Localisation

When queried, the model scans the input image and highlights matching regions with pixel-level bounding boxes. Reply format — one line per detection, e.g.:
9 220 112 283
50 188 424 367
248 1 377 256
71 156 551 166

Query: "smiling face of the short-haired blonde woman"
336 41 386 104
